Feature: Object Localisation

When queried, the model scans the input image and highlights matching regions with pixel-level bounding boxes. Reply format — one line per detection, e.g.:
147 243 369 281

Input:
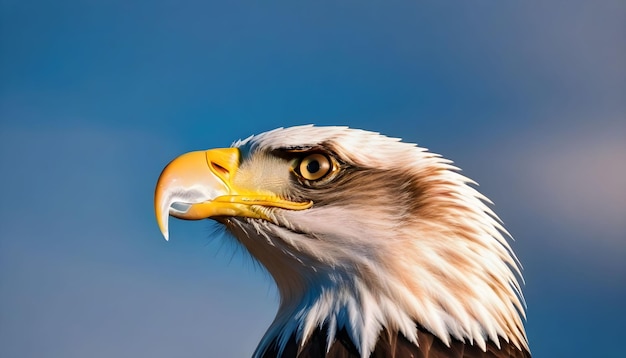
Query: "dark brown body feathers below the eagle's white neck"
262 329 530 358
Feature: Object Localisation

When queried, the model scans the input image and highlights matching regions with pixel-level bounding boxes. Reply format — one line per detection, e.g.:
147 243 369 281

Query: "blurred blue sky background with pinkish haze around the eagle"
0 0 626 358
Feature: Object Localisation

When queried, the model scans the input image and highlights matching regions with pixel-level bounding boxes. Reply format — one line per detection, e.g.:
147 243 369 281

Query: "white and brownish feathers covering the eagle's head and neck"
226 126 528 357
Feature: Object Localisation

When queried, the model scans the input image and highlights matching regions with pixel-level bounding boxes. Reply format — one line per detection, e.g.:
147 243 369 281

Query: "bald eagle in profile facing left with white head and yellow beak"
154 126 530 358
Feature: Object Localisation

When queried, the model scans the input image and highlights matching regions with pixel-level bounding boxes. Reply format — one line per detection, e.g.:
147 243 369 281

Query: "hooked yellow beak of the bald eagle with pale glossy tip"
154 148 312 240
